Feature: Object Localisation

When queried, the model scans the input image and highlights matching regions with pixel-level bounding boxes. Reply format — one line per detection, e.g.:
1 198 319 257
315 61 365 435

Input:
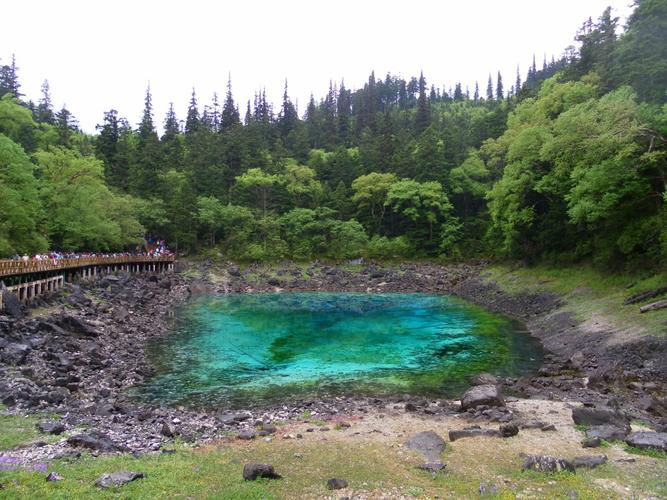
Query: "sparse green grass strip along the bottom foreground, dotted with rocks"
0 441 667 499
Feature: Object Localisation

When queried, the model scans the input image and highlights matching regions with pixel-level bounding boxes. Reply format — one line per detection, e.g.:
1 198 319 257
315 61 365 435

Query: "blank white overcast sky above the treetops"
0 0 631 132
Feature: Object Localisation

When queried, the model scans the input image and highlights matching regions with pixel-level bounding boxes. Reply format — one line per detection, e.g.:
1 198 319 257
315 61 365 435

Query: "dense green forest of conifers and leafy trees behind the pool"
0 0 667 267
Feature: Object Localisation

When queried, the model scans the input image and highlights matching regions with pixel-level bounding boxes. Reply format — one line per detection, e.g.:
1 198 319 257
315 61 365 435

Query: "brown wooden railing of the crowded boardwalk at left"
0 255 175 277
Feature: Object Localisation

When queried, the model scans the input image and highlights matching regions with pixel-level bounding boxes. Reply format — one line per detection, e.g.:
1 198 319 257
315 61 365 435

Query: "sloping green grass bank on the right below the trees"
488 264 667 335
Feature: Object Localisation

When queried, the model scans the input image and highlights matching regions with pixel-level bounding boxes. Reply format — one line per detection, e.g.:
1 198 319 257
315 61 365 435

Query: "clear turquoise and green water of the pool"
136 293 542 407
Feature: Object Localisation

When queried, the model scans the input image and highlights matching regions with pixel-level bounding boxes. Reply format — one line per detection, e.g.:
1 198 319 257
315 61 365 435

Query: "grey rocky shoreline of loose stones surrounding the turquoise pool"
0 263 667 462
